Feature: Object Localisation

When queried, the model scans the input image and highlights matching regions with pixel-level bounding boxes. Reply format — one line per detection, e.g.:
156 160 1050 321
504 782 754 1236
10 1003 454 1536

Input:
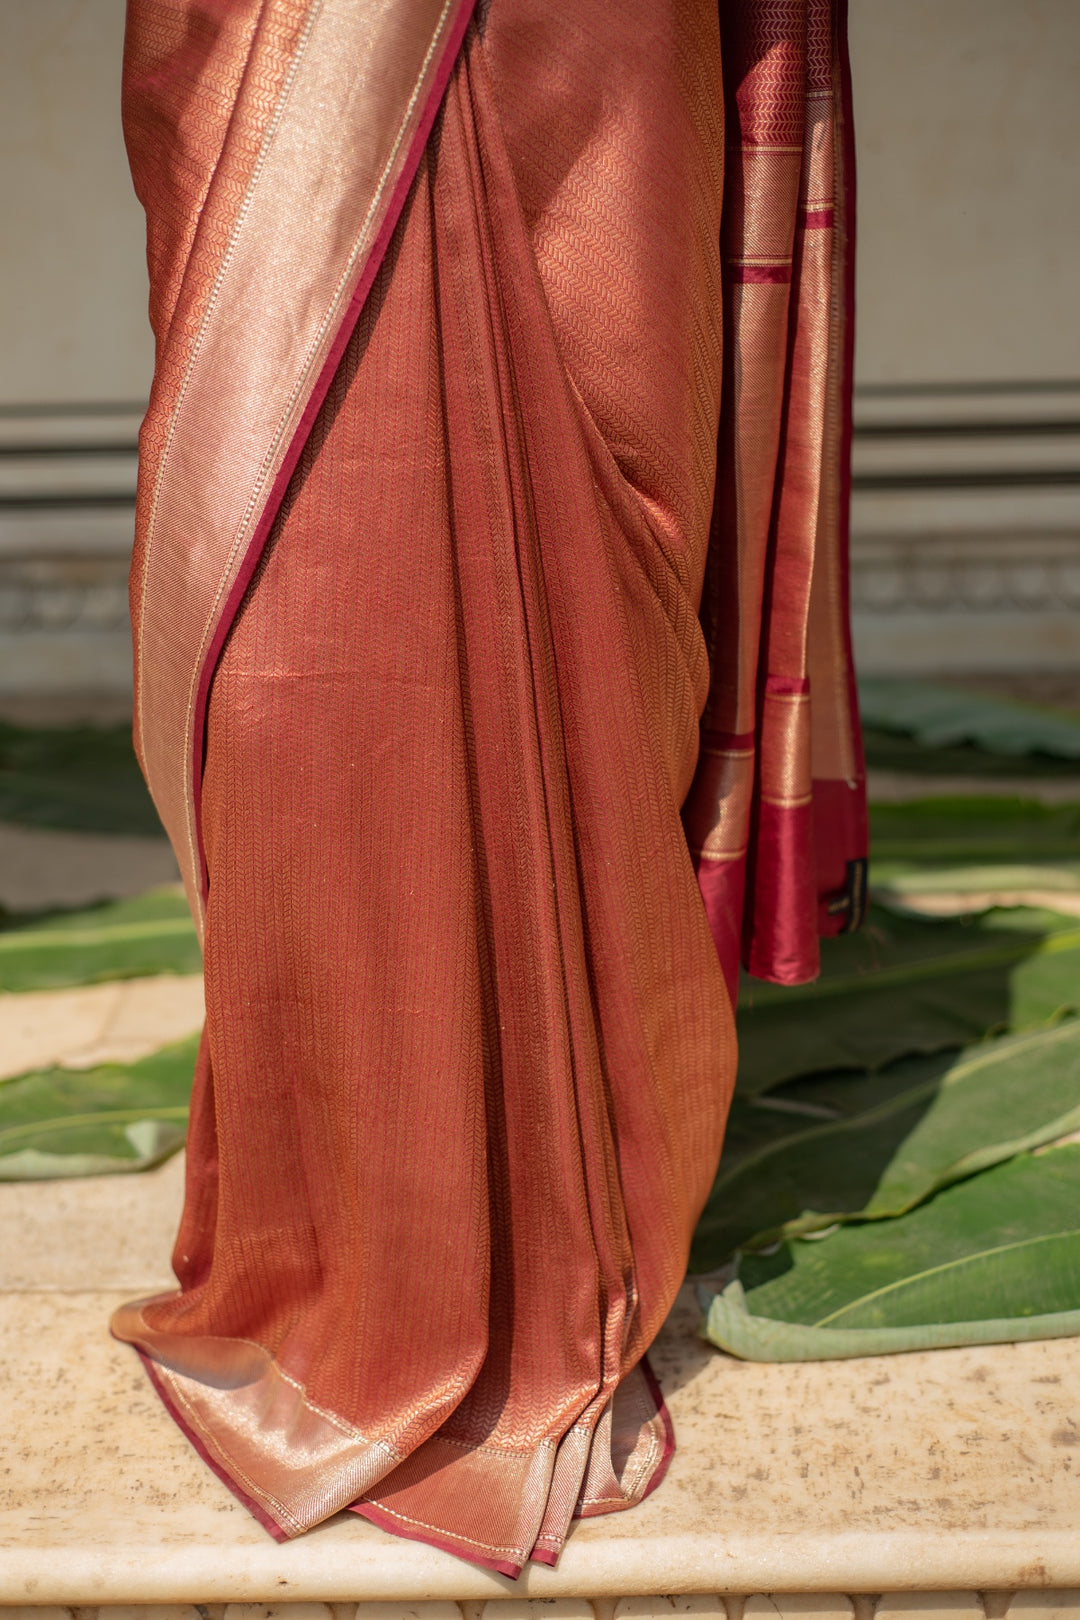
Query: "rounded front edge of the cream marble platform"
0 1523 1080 1605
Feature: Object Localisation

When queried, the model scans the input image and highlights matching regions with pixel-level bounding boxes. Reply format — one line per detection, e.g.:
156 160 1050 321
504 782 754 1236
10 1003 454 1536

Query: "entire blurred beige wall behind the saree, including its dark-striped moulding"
0 0 1080 695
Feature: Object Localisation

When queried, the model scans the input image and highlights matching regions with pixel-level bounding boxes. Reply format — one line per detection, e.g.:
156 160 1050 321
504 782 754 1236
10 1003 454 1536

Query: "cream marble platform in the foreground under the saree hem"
0 1140 1080 1620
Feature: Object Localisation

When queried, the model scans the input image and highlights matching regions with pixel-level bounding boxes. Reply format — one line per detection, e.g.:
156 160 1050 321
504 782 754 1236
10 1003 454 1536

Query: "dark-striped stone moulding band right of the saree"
852 384 1080 674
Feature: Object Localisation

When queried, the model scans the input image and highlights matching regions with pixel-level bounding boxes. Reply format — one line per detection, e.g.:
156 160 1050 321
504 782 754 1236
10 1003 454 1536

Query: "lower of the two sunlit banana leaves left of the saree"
0 1035 199 1181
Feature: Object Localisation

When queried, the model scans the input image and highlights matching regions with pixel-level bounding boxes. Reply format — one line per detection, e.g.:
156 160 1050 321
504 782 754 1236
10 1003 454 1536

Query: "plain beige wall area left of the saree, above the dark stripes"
0 0 152 405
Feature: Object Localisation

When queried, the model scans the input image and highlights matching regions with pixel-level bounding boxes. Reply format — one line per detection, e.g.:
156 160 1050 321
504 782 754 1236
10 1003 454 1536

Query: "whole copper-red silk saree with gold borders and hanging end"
113 0 863 1575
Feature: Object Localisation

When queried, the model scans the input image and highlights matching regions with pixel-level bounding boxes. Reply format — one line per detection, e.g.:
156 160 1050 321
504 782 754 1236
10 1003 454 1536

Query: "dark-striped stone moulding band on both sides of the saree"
0 384 1080 697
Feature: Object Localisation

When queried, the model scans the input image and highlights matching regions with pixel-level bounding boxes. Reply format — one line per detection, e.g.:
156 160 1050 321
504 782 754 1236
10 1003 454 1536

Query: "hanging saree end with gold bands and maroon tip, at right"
685 0 868 991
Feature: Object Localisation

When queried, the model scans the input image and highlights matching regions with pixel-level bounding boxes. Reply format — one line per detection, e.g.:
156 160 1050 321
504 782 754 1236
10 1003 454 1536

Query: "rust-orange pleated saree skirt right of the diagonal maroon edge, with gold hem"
117 0 733 1571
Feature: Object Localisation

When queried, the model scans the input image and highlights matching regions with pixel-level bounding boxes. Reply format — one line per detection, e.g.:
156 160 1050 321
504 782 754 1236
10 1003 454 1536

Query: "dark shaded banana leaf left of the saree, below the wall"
0 723 165 838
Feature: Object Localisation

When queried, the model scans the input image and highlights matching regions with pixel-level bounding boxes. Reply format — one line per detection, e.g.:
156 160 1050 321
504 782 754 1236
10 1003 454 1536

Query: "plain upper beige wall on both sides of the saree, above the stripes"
0 0 1080 403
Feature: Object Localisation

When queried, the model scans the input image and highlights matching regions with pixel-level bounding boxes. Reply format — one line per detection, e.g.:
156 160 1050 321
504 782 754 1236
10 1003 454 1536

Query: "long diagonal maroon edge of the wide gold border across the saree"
191 0 476 897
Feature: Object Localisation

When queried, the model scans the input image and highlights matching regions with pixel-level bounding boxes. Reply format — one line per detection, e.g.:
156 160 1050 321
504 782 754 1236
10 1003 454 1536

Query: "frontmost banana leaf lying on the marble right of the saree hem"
703 1145 1080 1361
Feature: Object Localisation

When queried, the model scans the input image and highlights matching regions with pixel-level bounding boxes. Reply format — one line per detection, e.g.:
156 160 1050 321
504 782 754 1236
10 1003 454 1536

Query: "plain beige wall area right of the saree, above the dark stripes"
850 0 1080 384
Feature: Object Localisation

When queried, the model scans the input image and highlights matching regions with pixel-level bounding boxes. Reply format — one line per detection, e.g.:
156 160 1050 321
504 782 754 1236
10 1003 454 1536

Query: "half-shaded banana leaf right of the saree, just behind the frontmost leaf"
690 1019 1080 1272
